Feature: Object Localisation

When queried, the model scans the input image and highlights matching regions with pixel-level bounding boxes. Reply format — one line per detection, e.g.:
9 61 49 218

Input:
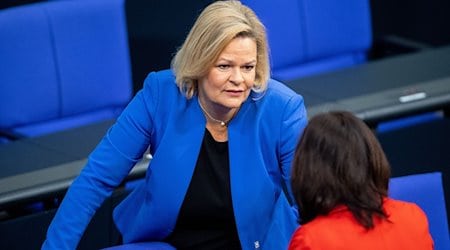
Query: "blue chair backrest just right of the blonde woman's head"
242 0 372 80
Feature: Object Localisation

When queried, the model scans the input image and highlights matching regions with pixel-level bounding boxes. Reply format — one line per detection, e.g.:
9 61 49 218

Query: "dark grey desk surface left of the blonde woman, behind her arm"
0 121 148 209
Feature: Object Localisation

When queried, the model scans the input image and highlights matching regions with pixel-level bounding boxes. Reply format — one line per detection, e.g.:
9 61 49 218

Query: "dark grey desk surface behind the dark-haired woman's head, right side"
286 46 450 122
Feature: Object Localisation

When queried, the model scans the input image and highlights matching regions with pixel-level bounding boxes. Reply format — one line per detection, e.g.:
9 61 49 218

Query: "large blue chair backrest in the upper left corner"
0 0 132 141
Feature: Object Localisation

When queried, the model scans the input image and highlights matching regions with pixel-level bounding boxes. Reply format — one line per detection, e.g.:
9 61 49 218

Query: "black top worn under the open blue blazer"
166 129 241 250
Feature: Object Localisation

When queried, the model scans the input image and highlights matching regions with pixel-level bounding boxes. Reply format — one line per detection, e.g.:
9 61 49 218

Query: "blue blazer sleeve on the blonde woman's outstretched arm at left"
42 71 158 249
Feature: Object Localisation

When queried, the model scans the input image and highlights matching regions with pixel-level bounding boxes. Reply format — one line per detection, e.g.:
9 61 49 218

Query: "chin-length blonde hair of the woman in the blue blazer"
172 0 270 99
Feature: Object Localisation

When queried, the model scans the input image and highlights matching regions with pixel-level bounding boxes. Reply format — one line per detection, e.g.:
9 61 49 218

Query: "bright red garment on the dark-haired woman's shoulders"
289 198 433 250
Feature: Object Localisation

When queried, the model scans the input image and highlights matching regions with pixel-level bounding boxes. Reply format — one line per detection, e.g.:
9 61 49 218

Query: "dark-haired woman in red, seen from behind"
289 111 433 250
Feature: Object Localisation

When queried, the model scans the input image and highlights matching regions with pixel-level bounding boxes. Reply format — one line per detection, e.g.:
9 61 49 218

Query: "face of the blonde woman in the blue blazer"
198 37 257 112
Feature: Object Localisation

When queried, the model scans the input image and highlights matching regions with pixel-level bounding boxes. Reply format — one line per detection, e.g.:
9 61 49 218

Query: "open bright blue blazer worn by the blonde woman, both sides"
43 70 307 249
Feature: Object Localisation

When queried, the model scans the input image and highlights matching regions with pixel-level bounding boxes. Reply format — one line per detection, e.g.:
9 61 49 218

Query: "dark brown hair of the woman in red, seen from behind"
292 111 390 228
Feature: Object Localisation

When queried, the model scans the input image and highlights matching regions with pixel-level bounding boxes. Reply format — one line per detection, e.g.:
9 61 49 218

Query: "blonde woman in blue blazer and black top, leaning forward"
43 1 307 249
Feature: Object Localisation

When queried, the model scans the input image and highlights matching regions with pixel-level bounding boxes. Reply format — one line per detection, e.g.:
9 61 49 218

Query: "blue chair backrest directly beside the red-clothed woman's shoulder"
389 172 450 250
